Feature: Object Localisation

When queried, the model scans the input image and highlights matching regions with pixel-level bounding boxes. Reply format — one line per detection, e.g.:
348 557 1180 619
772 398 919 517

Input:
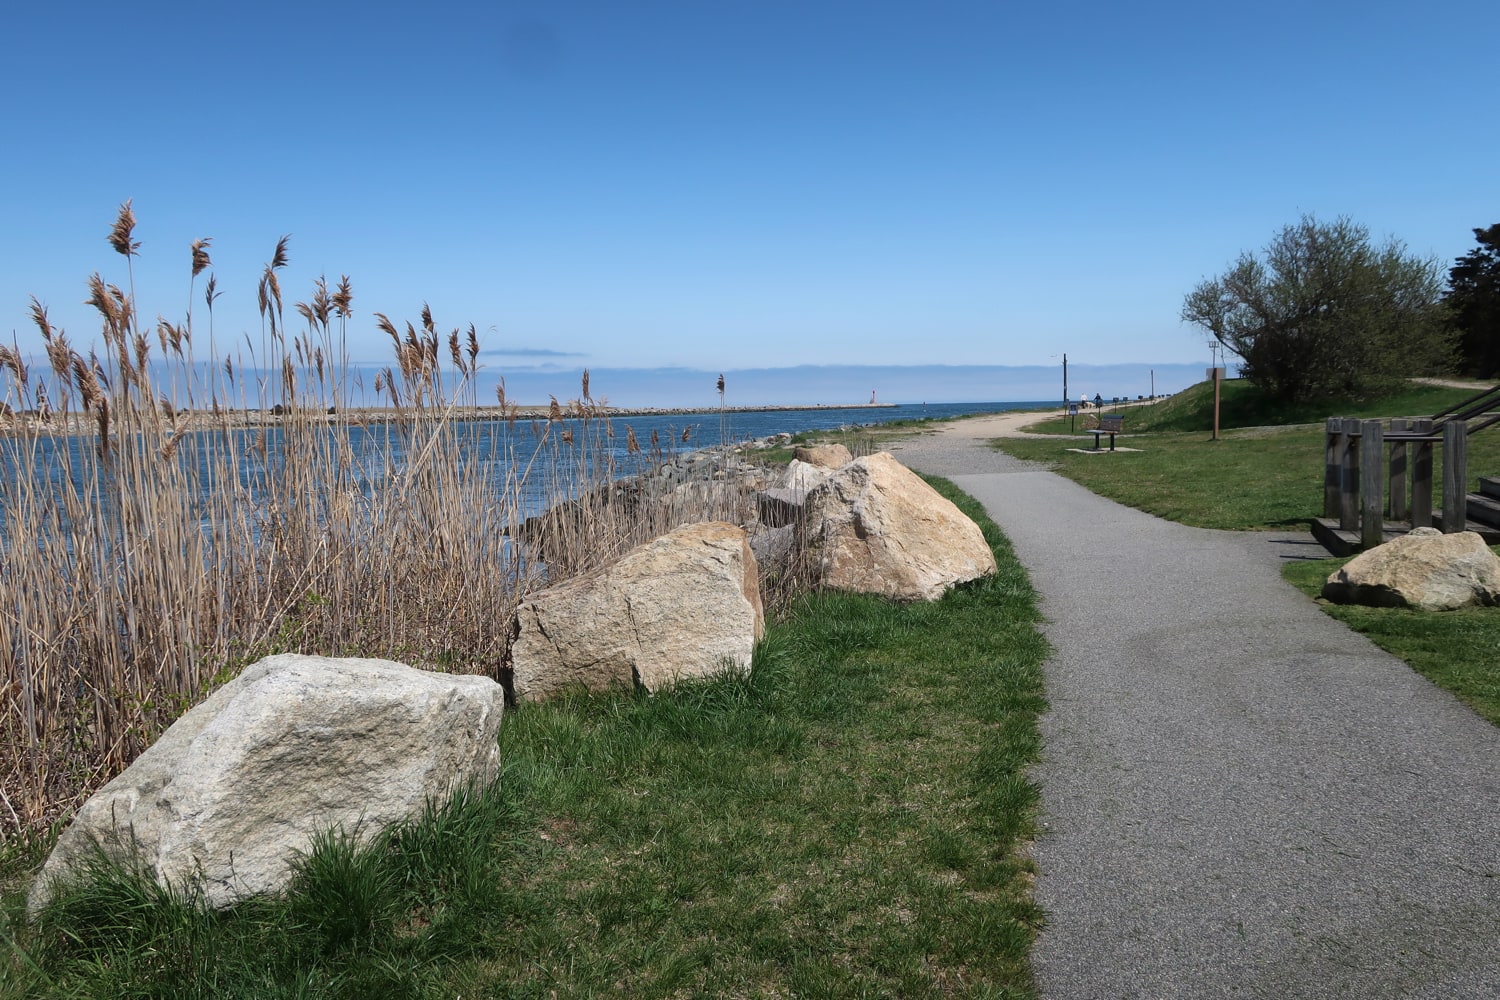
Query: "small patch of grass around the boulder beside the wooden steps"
1283 559 1500 726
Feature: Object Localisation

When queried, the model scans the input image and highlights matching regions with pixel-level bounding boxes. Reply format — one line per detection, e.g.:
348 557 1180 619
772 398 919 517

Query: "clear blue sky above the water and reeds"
0 0 1500 403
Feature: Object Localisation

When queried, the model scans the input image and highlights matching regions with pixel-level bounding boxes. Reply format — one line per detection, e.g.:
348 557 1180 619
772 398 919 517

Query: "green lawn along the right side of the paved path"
996 381 1500 724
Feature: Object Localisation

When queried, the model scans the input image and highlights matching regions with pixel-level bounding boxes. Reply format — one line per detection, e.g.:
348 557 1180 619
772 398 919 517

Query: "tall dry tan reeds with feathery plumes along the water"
0 202 744 841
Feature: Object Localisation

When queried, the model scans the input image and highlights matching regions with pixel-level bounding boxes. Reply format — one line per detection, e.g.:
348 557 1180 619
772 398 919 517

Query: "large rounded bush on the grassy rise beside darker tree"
1182 214 1454 400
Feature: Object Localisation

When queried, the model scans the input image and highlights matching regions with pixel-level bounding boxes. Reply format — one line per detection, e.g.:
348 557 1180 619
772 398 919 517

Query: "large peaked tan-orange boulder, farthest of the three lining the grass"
803 451 996 601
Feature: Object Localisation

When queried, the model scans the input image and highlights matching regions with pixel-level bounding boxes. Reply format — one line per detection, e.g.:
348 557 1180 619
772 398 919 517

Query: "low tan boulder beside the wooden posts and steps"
1323 528 1500 612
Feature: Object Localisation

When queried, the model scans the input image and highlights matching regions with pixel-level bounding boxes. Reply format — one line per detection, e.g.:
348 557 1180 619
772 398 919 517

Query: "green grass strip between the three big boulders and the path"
0 481 1047 997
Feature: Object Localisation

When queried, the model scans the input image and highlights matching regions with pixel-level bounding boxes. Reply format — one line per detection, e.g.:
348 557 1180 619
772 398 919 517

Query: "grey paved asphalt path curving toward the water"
891 429 1500 1000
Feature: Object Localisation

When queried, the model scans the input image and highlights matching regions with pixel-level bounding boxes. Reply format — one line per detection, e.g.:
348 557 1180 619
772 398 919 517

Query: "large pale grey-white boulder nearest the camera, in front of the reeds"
29 654 504 913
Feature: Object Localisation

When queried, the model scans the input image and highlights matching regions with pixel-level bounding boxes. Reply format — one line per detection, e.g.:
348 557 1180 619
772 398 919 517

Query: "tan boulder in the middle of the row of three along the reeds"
512 522 765 702
